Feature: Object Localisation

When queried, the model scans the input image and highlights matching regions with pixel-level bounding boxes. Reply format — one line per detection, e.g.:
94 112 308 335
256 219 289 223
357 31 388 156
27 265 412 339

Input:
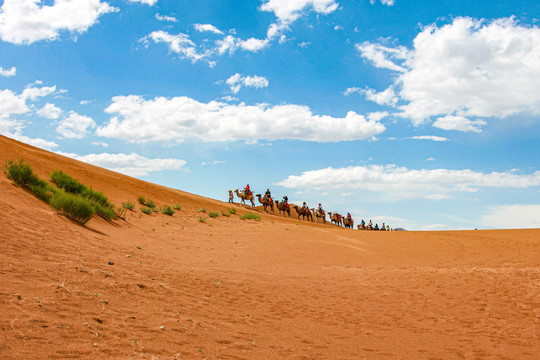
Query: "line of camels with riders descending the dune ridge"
229 184 391 231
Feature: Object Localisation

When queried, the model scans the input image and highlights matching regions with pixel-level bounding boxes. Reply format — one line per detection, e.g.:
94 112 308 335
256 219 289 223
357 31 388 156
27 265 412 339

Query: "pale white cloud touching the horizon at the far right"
478 204 540 229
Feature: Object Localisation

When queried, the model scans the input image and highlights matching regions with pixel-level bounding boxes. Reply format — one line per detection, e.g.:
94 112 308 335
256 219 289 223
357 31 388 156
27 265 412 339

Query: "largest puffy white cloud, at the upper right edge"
357 18 540 126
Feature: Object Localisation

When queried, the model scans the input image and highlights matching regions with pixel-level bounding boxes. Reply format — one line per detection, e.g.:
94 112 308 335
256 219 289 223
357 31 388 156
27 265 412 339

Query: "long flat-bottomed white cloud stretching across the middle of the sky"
96 95 385 142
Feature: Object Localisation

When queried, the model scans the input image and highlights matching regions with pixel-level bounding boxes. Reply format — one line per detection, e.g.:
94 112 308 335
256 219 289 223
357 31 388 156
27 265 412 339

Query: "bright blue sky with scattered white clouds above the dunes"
0 0 540 230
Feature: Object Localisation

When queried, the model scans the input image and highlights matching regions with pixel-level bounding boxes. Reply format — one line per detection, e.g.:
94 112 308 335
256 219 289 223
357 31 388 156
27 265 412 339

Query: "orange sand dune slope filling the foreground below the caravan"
0 137 540 360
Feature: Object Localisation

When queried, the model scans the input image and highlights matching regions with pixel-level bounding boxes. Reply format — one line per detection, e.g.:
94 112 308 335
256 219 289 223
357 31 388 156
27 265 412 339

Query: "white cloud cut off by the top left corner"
0 0 117 44
